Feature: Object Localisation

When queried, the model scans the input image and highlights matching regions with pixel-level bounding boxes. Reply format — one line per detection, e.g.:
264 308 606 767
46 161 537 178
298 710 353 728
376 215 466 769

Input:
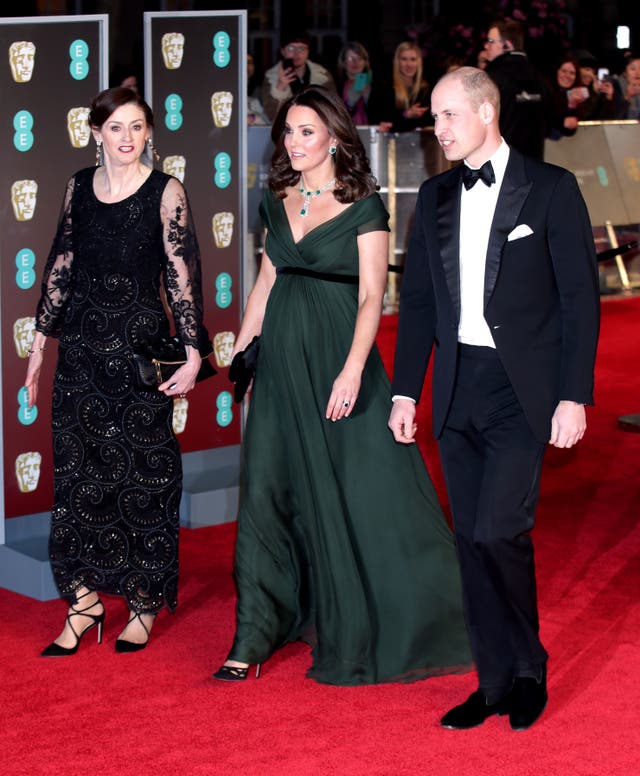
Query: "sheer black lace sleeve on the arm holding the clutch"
160 178 206 349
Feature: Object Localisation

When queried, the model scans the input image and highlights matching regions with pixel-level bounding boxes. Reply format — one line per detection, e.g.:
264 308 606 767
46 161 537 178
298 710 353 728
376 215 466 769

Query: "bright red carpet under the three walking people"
0 299 640 776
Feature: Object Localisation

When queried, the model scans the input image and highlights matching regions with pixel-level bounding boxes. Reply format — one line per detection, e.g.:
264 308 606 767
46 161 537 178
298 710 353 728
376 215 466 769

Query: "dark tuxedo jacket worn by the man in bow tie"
392 149 600 443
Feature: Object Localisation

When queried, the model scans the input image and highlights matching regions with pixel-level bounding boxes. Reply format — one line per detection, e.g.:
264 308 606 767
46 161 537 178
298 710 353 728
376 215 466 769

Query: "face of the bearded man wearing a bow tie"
431 79 490 167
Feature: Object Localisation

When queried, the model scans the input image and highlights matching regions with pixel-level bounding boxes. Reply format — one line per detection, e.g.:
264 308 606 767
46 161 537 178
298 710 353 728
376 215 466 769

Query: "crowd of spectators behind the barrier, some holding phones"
247 24 640 144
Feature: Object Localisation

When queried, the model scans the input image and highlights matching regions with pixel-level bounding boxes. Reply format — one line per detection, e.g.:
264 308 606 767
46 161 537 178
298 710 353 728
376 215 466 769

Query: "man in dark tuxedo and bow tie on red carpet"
389 67 599 730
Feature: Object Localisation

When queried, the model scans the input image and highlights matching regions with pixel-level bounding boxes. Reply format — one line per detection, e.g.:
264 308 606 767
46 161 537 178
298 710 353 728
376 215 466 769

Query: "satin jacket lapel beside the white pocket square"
484 149 533 309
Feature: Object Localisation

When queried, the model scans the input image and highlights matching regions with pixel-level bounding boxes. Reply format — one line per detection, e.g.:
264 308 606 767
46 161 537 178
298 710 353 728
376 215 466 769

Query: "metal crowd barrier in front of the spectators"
245 121 640 304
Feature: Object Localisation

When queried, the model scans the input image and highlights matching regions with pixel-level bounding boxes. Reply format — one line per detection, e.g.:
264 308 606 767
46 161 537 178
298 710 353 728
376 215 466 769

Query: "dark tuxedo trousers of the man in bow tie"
440 345 547 703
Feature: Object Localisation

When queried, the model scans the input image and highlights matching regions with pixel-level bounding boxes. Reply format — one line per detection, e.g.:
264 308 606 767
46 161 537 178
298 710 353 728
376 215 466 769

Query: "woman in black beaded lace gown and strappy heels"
25 87 207 657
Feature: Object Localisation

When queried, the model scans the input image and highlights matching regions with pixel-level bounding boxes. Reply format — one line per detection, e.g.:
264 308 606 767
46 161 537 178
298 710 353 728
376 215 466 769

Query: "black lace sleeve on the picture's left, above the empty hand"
36 177 75 337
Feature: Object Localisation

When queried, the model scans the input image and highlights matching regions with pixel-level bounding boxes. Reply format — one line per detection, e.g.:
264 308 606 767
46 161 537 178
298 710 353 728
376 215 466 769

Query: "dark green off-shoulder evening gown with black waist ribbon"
229 192 471 685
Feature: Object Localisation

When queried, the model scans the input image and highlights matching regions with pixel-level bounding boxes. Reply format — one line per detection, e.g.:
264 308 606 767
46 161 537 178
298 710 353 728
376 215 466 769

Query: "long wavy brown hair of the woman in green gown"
269 86 378 203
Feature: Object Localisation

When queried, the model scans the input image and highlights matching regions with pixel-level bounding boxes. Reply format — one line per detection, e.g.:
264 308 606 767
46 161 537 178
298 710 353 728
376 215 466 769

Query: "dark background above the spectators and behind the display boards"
2 0 640 93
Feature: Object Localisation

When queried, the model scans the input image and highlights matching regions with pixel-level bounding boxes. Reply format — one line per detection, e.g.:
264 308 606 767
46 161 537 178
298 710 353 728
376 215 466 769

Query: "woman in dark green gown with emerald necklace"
214 86 471 685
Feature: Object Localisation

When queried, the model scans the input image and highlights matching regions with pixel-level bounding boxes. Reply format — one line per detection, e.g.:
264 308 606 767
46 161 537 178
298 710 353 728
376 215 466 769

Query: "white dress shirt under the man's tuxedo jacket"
458 140 509 348
